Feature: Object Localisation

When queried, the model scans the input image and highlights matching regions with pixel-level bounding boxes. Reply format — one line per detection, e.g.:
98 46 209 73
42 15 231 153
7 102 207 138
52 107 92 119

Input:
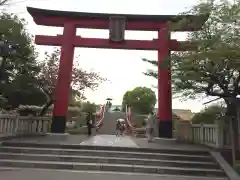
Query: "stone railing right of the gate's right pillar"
175 121 230 148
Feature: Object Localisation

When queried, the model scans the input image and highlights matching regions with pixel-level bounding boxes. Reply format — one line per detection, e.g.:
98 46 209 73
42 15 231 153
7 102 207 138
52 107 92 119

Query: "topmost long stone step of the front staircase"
2 141 210 155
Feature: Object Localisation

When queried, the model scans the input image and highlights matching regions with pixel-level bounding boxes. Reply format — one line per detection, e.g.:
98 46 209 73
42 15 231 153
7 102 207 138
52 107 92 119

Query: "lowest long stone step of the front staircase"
0 159 225 177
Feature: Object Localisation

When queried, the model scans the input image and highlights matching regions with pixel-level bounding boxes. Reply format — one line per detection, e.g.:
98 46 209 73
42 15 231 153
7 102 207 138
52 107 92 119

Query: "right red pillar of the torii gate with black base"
157 24 173 138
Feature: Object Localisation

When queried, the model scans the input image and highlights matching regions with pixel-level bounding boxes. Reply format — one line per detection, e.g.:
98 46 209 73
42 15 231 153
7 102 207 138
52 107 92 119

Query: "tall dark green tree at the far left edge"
0 13 45 107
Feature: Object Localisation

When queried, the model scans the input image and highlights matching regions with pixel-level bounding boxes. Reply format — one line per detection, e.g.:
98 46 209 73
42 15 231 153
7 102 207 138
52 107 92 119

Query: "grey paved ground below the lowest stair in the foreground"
0 169 227 180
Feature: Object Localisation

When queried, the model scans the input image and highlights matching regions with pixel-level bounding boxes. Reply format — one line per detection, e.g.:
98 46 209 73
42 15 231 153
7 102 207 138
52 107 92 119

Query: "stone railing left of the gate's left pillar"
0 114 51 135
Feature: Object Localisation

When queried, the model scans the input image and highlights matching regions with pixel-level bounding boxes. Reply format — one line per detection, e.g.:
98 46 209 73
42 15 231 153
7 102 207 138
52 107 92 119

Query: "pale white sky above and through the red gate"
4 0 216 112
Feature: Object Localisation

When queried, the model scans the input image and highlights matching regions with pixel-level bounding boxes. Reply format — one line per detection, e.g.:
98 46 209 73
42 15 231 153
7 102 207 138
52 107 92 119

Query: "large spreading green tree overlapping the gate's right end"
144 0 240 161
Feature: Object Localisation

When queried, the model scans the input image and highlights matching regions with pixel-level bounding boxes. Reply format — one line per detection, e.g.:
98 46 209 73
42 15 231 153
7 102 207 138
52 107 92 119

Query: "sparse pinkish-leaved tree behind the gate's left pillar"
39 49 106 114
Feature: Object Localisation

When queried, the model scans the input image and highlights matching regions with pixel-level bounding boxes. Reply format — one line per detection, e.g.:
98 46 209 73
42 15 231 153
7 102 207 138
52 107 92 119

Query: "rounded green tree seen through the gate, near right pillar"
122 87 157 114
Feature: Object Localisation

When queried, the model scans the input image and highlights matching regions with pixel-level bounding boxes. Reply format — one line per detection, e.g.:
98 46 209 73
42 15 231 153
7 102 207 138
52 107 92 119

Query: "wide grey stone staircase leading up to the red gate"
0 141 228 180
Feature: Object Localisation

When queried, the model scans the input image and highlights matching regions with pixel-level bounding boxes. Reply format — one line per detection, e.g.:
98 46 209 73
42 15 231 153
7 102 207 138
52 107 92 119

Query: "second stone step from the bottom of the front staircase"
0 153 220 169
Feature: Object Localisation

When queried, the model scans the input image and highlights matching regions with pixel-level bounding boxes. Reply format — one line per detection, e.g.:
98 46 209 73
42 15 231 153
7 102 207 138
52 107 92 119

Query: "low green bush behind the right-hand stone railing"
192 105 226 124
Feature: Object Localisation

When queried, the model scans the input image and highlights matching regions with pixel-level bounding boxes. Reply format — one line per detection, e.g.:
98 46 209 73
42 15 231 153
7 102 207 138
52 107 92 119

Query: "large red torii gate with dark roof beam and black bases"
27 7 208 138
